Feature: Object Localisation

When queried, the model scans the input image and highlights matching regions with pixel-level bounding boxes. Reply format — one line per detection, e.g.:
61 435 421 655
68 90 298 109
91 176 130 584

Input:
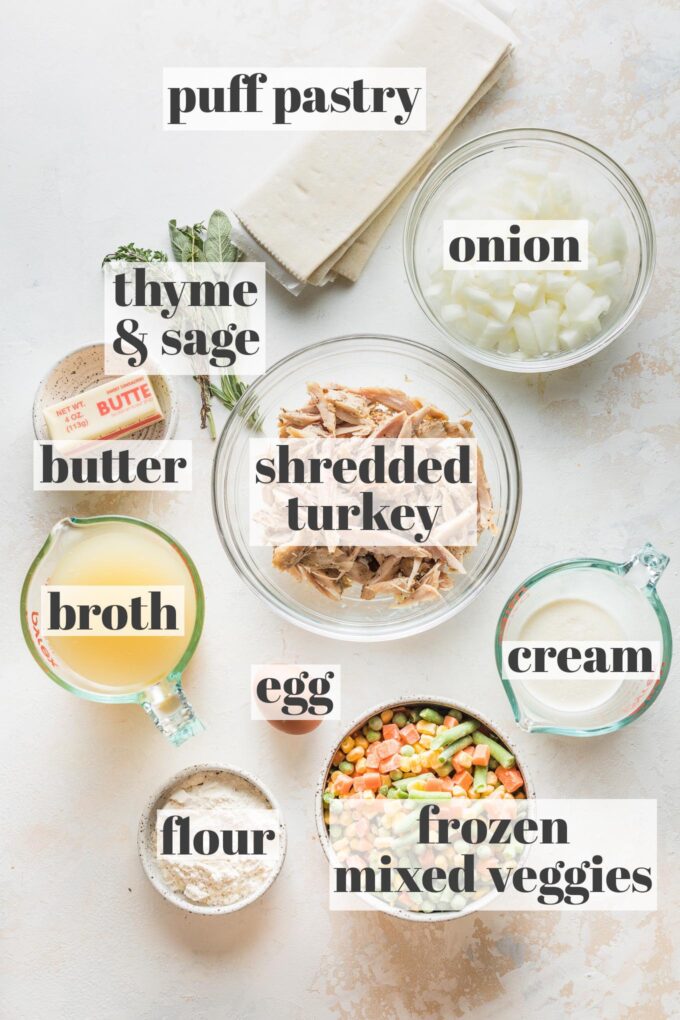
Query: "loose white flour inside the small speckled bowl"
158 773 278 907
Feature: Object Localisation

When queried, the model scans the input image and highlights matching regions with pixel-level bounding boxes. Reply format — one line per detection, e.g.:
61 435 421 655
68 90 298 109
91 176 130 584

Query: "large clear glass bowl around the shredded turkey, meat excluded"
212 335 521 641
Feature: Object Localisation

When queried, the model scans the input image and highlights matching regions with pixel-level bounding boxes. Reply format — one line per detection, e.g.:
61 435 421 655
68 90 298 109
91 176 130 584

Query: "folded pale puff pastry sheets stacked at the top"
234 0 515 292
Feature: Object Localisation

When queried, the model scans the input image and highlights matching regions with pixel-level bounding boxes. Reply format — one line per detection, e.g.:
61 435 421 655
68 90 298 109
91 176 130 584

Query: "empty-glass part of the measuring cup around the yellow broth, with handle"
20 515 205 746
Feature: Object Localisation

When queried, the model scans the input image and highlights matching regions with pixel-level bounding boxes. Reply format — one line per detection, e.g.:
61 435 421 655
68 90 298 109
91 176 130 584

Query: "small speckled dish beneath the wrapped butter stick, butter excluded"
33 344 179 440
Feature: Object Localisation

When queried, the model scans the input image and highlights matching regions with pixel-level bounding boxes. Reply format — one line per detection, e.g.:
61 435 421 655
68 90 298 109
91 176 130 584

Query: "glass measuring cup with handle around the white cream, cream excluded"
495 543 673 736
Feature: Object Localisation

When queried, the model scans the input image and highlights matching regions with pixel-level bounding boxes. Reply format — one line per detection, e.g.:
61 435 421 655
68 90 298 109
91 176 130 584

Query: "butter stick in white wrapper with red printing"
44 372 163 440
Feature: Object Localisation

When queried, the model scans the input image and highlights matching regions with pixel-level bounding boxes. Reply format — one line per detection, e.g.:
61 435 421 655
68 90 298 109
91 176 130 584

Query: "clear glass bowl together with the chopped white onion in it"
404 129 656 372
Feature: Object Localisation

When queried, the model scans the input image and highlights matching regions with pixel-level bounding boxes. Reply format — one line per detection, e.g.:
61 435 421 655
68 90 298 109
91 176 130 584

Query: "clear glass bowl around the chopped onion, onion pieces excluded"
404 128 656 372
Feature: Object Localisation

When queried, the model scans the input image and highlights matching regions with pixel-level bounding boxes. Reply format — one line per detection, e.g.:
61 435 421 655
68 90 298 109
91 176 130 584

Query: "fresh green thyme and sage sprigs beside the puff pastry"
102 209 255 440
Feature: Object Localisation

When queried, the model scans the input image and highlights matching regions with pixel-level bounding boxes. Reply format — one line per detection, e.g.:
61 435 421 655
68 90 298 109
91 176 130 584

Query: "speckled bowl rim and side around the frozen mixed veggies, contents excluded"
315 695 536 924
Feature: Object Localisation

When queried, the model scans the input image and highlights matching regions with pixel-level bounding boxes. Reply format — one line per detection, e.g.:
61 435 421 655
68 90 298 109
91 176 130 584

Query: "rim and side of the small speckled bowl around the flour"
137 764 286 916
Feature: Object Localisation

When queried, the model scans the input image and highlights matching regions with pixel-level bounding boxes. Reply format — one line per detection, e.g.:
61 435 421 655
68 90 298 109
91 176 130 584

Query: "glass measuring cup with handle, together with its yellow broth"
20 515 205 746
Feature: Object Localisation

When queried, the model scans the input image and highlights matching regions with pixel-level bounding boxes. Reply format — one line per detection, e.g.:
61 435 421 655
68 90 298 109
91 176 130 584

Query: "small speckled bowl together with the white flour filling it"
138 765 286 915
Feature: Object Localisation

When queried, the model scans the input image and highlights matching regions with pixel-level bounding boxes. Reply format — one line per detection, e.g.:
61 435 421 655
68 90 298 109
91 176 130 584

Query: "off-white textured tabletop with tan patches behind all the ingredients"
1 0 680 1020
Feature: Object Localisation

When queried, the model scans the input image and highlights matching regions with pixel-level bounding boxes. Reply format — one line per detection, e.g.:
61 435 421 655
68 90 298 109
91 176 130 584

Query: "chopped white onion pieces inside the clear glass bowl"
424 157 627 359
